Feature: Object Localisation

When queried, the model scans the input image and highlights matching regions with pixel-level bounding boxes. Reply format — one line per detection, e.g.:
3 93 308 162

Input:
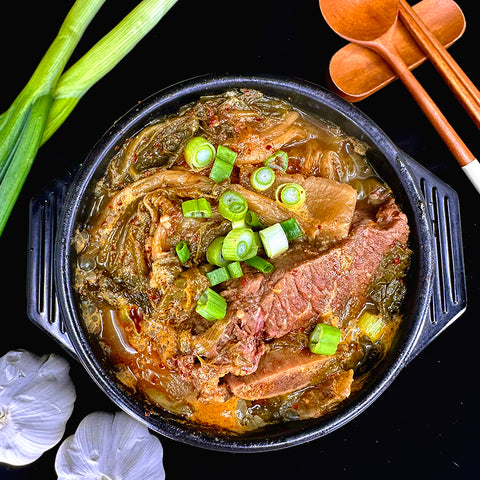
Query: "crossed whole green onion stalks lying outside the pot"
0 0 177 235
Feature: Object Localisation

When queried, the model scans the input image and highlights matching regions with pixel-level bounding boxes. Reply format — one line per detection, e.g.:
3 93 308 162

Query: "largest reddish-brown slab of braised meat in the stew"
191 200 409 400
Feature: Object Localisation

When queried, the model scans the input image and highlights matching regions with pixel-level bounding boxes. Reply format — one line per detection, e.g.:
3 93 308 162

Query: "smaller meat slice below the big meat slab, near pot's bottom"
226 348 330 400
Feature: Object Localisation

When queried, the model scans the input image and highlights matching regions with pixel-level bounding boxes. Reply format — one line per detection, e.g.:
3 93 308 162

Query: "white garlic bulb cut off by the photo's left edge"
0 350 76 465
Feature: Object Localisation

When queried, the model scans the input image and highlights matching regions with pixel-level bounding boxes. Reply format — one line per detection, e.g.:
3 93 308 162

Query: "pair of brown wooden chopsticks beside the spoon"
399 0 480 129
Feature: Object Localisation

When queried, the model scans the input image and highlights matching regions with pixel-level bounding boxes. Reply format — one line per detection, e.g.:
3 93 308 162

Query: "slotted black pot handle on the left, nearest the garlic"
26 176 77 358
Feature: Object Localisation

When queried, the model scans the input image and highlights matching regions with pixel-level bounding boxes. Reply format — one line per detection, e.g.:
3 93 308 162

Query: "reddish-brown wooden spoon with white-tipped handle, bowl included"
319 0 480 193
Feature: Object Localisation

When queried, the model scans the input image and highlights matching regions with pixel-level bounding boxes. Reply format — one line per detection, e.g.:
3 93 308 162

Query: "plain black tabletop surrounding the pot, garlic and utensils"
0 0 480 480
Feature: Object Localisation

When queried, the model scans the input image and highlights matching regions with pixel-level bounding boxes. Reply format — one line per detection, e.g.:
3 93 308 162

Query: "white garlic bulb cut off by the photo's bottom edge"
55 412 165 480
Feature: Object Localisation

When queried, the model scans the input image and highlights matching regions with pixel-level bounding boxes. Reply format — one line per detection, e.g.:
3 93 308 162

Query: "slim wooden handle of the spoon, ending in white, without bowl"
376 35 480 193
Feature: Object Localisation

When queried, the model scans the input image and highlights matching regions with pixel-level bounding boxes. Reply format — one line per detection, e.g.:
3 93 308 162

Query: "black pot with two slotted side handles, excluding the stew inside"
28 76 466 452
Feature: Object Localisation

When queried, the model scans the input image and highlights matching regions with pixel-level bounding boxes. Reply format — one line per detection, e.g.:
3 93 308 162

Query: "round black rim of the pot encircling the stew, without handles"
54 75 433 452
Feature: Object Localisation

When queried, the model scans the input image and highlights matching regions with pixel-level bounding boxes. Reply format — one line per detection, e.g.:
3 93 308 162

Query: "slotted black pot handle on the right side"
405 155 467 362
